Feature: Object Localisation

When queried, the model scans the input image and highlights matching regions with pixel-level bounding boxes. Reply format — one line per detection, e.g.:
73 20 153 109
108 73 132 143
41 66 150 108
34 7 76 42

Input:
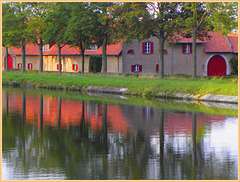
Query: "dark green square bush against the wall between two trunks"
89 55 102 73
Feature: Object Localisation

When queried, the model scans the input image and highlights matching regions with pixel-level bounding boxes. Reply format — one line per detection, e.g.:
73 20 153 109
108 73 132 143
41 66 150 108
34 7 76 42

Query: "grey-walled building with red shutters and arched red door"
122 32 238 76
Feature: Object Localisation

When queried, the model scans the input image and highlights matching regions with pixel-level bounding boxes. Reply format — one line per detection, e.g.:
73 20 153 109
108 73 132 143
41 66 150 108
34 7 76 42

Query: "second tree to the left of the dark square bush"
43 3 70 74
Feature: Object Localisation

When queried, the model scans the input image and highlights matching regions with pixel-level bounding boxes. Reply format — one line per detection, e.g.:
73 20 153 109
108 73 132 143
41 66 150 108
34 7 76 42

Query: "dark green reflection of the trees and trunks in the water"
2 91 236 179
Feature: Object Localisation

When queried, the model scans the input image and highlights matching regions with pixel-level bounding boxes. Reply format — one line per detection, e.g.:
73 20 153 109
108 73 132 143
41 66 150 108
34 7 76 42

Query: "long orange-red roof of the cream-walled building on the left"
13 42 122 55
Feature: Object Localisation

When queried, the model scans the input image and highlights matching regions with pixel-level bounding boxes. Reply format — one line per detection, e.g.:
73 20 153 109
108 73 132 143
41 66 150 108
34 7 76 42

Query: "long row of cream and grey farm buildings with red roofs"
2 32 238 76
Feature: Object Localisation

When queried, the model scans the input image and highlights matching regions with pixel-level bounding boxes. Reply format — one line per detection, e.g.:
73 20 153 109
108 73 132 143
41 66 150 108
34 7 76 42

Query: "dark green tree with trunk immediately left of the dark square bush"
65 2 96 73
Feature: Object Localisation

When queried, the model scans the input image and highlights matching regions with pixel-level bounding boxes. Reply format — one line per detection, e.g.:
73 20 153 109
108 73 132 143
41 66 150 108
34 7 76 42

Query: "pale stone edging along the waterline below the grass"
2 81 238 104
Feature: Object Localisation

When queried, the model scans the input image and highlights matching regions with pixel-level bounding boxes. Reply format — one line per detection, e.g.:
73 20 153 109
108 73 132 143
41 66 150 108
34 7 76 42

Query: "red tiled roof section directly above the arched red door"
204 32 233 52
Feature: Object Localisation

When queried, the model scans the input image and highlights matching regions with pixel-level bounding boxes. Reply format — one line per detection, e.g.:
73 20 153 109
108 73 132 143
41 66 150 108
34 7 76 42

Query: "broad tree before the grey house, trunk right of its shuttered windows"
114 2 183 78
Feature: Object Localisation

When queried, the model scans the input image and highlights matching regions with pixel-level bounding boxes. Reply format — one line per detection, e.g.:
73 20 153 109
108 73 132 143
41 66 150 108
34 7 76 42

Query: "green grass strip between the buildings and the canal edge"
2 72 238 96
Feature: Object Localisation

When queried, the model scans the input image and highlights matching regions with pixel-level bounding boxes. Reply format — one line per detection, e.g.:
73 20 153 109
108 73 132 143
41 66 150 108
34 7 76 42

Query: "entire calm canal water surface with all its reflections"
2 88 238 180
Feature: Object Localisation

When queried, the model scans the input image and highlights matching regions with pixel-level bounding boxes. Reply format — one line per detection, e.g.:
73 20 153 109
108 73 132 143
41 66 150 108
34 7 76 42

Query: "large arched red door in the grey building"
207 56 227 76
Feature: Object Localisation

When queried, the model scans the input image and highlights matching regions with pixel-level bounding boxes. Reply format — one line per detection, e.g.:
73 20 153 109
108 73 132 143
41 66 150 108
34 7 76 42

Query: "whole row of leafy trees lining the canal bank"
3 2 238 78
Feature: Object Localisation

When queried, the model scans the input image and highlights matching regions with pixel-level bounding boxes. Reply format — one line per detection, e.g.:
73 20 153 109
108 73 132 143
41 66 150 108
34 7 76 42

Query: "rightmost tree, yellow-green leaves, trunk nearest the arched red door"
184 2 237 79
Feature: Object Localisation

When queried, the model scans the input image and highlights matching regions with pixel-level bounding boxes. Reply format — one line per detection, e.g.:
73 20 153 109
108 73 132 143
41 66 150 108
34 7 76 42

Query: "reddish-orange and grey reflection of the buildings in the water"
3 92 225 136
